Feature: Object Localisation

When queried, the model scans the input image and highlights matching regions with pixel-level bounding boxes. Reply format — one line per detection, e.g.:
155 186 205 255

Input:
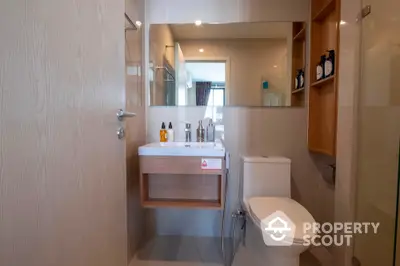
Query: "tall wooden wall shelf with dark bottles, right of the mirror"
308 0 340 157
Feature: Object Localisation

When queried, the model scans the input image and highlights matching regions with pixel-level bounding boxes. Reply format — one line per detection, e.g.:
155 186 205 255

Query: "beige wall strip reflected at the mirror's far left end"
149 25 175 105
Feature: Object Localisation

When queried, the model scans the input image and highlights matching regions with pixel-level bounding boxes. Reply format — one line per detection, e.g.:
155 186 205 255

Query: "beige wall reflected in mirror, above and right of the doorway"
179 39 291 106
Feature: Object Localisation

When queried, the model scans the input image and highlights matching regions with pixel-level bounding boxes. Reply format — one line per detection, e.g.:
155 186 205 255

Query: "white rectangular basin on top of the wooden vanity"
139 142 225 157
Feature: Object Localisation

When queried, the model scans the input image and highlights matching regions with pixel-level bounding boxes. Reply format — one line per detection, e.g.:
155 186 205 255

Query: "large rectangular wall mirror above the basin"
149 21 307 107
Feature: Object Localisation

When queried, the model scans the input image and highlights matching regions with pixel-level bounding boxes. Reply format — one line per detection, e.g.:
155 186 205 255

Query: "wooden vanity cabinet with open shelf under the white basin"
139 156 225 209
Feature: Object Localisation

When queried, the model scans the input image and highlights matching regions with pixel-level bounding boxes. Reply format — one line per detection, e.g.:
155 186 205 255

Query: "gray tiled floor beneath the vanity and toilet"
130 236 320 266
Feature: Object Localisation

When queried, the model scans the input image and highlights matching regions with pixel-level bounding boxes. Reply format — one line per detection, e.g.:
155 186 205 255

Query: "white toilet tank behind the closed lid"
241 156 291 200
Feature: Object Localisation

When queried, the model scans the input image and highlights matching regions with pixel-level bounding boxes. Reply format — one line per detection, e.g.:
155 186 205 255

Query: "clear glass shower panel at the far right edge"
354 0 400 266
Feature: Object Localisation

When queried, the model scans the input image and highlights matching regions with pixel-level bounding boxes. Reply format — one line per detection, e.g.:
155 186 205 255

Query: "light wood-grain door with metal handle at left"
0 0 127 266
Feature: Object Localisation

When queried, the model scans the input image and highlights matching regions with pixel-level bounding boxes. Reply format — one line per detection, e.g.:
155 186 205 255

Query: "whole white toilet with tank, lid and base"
235 157 315 266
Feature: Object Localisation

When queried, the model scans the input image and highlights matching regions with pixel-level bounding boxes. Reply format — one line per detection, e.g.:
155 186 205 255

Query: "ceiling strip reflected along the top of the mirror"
170 22 292 41
